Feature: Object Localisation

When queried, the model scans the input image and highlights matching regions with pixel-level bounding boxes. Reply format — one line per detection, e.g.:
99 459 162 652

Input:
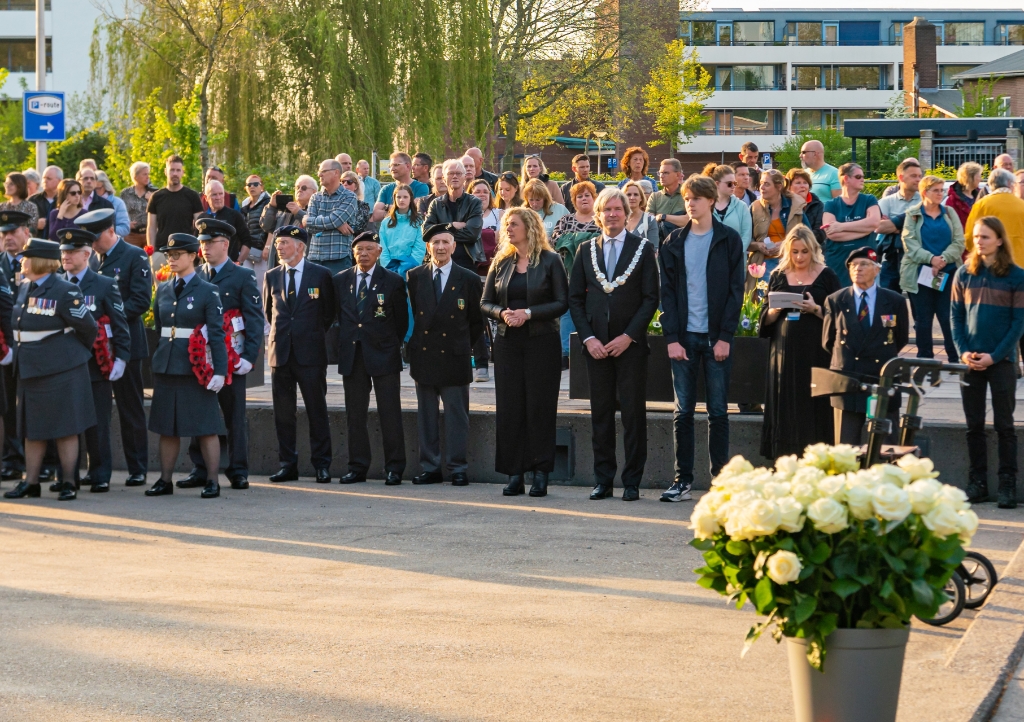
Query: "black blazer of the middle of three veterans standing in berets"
334 264 405 376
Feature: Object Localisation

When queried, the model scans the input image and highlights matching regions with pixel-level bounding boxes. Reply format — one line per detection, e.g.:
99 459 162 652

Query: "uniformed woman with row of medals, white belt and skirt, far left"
4 239 96 502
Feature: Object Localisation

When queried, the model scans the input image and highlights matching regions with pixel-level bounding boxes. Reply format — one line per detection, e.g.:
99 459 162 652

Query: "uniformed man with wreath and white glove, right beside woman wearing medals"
58 228 131 493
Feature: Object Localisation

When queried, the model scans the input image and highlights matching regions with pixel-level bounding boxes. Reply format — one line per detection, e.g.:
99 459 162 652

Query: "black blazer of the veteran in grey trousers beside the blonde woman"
407 261 483 386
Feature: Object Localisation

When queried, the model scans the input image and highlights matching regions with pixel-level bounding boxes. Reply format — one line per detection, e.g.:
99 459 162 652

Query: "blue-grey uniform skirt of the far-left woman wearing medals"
17 364 96 441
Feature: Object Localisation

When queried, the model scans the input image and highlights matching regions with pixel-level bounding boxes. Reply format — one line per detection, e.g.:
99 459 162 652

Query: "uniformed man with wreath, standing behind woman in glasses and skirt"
177 216 263 489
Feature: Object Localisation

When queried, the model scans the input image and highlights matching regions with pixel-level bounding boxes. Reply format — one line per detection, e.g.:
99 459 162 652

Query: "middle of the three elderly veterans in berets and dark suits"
334 232 409 484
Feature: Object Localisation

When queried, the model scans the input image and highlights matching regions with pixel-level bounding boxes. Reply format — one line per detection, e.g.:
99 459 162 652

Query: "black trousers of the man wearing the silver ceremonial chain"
585 343 647 486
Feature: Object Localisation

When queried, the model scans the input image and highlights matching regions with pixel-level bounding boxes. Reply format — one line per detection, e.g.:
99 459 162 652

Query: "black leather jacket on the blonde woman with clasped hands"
480 251 569 336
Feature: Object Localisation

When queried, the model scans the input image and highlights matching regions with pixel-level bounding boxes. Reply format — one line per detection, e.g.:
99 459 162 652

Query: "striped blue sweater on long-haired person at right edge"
949 265 1024 364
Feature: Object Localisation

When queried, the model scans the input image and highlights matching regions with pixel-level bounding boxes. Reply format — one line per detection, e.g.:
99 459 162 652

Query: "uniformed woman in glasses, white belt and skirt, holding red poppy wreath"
145 233 227 499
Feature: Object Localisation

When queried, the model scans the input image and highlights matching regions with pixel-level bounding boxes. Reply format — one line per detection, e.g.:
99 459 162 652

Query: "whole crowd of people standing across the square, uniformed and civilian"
0 140 1024 506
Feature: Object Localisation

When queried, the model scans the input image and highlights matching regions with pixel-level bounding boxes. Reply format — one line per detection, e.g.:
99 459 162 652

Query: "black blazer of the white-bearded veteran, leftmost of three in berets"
263 258 337 367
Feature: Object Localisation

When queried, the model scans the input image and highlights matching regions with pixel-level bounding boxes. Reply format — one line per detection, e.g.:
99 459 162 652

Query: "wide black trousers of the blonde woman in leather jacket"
495 329 562 476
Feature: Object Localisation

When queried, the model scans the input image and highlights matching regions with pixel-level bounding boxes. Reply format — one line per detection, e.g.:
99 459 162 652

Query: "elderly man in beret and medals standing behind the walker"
821 247 910 445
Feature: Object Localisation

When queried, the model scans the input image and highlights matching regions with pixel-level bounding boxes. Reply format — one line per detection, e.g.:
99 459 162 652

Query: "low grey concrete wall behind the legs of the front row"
112 399 1024 496
